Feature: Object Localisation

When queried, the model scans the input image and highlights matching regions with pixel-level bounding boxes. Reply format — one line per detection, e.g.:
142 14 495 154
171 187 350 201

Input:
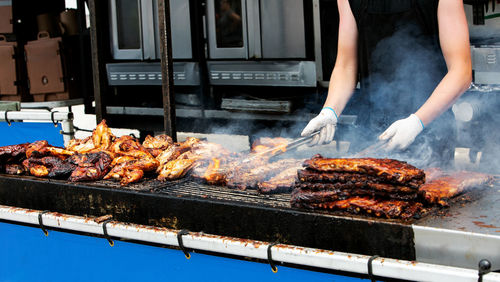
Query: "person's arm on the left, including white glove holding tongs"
301 0 358 145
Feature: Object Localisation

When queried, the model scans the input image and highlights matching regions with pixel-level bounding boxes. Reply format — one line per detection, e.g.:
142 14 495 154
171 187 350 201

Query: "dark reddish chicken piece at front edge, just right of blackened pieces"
68 151 113 182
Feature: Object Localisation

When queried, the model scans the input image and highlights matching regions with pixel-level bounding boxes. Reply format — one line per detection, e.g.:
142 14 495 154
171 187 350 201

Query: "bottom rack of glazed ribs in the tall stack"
292 197 425 219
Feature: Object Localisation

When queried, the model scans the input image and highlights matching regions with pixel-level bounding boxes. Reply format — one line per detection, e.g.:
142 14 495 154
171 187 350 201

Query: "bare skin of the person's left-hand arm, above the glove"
324 0 358 115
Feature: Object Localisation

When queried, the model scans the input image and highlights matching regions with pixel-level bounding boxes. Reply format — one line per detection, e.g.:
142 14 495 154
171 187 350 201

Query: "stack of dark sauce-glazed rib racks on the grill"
291 155 425 219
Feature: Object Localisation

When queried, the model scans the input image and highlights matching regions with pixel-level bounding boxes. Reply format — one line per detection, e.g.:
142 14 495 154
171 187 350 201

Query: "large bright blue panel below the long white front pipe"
0 222 367 282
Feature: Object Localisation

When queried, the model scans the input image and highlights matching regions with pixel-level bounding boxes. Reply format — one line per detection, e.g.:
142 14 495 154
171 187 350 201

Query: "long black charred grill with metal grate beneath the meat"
0 175 500 260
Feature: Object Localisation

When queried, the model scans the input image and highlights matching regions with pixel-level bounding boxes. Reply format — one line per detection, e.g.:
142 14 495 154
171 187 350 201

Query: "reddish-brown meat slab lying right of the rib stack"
419 171 493 206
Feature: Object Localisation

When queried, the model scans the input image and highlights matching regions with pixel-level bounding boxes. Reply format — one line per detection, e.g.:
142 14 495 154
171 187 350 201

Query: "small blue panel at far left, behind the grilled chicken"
0 122 64 146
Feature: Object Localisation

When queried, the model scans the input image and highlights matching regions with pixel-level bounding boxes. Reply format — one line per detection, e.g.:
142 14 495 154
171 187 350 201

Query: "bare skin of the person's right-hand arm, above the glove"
415 0 472 125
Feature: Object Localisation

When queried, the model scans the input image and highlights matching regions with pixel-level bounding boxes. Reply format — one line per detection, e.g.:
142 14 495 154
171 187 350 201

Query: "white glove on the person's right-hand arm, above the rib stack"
378 114 424 151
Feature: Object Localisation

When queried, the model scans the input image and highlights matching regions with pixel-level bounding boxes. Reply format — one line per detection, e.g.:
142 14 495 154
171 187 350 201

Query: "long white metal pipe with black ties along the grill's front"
0 205 500 281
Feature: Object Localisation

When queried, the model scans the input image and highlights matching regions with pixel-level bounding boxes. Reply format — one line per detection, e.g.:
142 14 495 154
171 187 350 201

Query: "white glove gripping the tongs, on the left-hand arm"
300 107 337 146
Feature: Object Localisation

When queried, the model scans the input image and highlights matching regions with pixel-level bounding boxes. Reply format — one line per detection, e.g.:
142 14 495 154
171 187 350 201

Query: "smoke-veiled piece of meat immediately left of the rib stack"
227 159 300 190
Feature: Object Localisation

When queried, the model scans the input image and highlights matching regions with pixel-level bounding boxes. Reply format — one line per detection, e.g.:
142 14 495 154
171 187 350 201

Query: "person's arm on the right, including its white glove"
379 0 472 151
